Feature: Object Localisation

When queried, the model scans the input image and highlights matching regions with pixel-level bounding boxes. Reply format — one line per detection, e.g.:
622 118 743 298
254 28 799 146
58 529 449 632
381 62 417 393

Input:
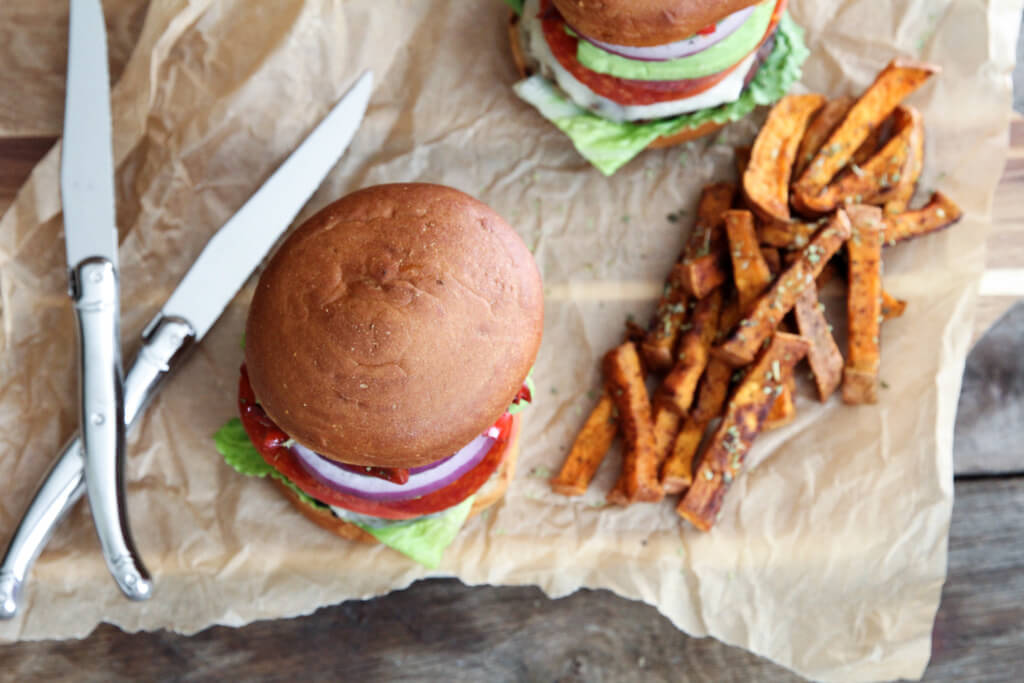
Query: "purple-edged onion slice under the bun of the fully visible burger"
291 427 500 501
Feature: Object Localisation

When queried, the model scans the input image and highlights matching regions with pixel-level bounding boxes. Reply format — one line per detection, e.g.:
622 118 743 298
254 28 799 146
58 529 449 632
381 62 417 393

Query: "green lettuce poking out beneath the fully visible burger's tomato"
213 418 475 568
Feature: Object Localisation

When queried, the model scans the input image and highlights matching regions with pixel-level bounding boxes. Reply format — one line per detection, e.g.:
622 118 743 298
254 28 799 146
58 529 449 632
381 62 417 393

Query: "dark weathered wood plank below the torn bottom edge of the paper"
0 478 1024 682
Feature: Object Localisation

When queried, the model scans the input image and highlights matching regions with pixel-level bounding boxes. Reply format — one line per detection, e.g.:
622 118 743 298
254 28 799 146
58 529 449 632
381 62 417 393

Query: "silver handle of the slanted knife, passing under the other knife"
0 315 196 618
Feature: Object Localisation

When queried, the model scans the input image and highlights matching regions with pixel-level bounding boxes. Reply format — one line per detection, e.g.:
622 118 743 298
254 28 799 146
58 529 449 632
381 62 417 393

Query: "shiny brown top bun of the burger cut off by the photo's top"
553 0 760 47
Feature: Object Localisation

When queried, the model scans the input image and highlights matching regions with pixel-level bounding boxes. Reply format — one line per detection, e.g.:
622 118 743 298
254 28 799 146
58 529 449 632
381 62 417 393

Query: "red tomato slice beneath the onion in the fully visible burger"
239 366 519 519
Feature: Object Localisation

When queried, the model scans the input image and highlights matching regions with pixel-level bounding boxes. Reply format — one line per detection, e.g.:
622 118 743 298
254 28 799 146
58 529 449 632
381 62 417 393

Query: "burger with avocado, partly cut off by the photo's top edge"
510 0 808 175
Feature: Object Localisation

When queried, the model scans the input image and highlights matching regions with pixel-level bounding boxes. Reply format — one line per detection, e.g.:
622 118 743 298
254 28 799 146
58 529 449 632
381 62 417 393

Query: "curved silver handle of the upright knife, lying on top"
71 257 153 600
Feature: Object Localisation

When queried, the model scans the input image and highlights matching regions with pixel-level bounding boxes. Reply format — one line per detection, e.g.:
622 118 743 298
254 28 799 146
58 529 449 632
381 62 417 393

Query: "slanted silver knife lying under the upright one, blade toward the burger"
0 72 373 618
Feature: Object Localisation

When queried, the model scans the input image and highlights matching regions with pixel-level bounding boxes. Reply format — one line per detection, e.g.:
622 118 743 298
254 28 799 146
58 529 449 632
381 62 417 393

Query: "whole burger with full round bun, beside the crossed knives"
215 183 544 566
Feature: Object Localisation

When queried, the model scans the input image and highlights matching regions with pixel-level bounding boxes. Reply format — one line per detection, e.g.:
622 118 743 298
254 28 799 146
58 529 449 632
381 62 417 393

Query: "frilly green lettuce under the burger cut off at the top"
514 12 810 175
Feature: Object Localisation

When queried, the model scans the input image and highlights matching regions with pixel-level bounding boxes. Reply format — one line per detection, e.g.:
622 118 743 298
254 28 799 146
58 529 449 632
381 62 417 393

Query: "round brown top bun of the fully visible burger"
246 183 544 467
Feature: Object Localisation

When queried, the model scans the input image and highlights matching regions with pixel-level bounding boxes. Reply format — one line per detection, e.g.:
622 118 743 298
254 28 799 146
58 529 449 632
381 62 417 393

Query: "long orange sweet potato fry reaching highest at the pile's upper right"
794 57 939 201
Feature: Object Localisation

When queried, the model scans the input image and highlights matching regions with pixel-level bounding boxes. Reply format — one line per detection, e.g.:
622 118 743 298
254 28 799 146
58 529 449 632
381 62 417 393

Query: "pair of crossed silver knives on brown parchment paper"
0 0 373 618
